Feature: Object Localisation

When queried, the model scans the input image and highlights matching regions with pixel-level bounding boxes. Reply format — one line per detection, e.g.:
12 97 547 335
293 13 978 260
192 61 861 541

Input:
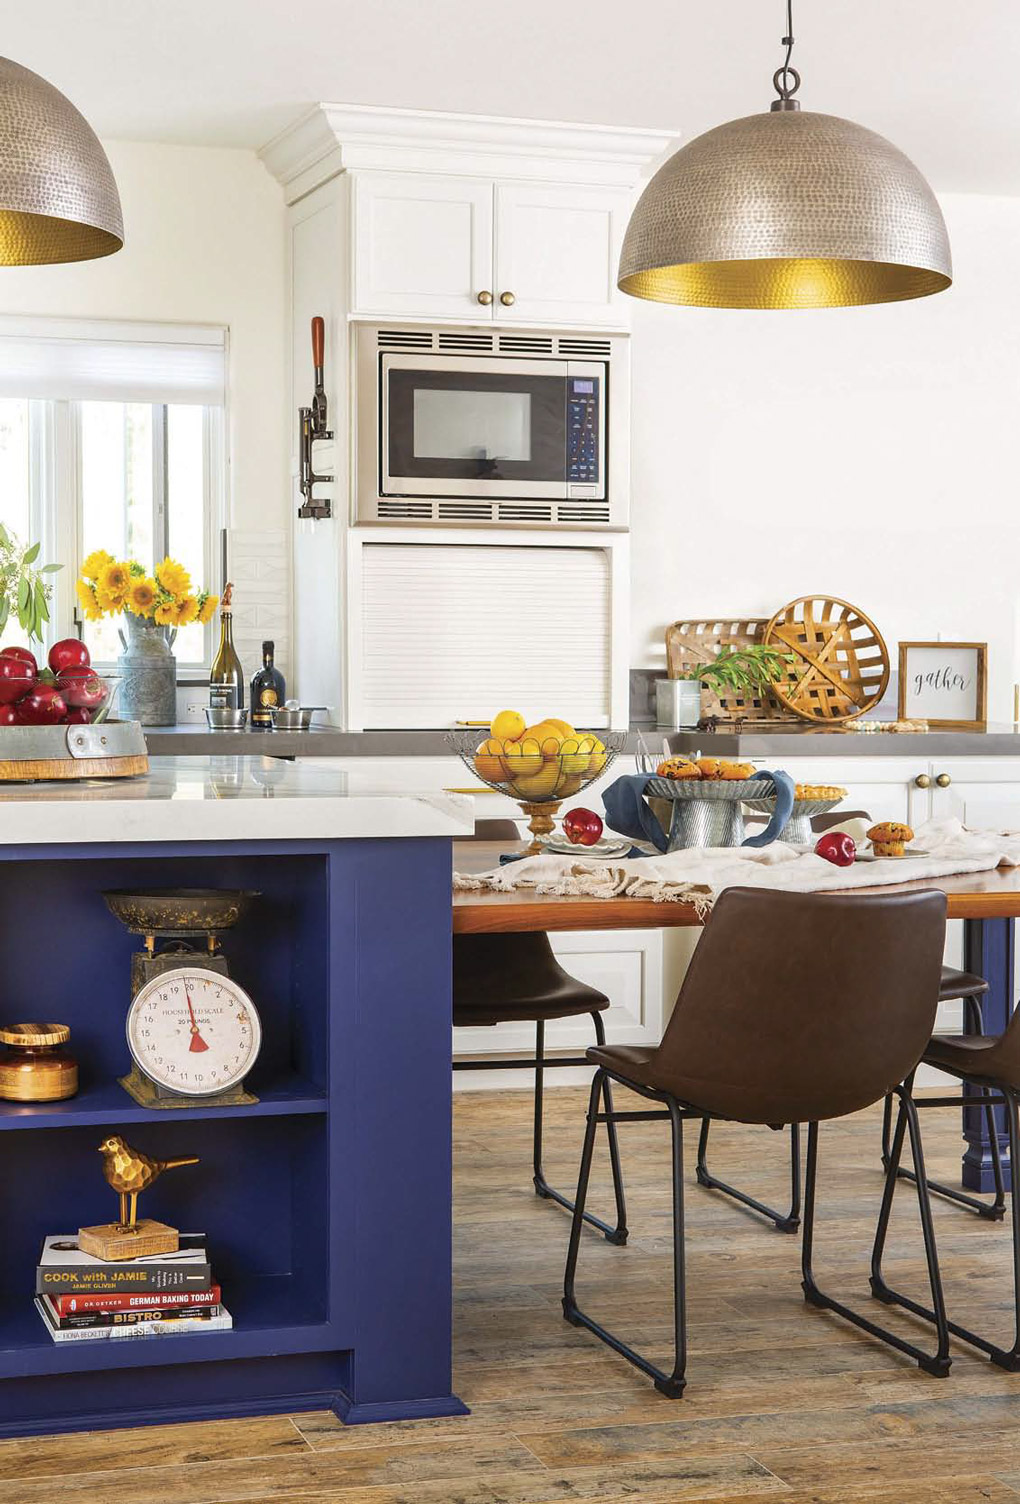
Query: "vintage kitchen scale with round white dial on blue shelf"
102 887 262 1107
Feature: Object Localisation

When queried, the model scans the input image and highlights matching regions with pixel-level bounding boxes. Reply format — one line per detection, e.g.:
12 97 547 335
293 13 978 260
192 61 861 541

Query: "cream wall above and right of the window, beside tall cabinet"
0 141 290 531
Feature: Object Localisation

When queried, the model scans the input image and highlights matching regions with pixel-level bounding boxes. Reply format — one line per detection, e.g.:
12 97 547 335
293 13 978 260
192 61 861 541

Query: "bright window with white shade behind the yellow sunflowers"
0 319 226 675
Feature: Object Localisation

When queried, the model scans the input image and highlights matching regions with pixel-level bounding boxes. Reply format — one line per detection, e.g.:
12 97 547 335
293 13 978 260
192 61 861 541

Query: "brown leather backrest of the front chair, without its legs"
642 887 946 1123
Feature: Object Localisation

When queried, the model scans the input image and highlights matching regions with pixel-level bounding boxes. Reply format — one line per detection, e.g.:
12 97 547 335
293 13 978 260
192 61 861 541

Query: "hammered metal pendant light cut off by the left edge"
0 57 123 266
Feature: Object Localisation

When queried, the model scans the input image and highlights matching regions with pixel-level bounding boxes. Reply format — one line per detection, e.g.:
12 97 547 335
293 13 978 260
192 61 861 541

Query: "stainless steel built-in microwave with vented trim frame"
355 325 629 529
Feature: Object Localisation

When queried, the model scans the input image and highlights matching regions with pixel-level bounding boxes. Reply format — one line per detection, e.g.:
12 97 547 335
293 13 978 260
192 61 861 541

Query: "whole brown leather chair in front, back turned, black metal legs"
563 887 949 1399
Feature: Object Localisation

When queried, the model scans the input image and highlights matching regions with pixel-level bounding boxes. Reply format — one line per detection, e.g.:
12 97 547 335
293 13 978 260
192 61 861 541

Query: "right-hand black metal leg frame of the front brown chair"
800 1087 949 1378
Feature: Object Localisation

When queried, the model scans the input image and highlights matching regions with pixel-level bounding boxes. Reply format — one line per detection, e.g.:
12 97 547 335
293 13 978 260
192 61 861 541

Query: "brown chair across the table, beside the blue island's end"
453 820 627 1245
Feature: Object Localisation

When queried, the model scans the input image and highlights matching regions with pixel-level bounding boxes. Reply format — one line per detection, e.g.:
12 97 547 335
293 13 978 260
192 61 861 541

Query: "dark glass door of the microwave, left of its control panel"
385 368 566 495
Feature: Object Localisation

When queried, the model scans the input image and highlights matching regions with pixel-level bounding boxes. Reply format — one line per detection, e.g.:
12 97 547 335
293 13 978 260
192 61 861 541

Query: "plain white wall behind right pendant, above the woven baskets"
632 194 1020 720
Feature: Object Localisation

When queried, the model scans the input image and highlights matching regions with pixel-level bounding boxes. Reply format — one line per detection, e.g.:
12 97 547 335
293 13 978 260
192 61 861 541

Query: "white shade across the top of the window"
0 317 227 408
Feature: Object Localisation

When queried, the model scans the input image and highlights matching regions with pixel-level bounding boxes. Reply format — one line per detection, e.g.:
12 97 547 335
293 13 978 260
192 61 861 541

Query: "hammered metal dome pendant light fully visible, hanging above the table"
618 0 952 308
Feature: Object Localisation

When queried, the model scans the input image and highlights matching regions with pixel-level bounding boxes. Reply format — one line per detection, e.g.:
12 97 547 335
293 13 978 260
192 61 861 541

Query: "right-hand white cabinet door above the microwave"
493 183 630 325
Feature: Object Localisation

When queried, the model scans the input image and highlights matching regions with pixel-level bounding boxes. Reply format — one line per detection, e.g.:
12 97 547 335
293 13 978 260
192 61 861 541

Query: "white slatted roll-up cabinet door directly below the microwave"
360 543 611 729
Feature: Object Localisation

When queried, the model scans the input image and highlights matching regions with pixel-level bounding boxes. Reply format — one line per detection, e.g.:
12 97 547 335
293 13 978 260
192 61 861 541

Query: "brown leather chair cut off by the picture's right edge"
873 1009 1020 1373
